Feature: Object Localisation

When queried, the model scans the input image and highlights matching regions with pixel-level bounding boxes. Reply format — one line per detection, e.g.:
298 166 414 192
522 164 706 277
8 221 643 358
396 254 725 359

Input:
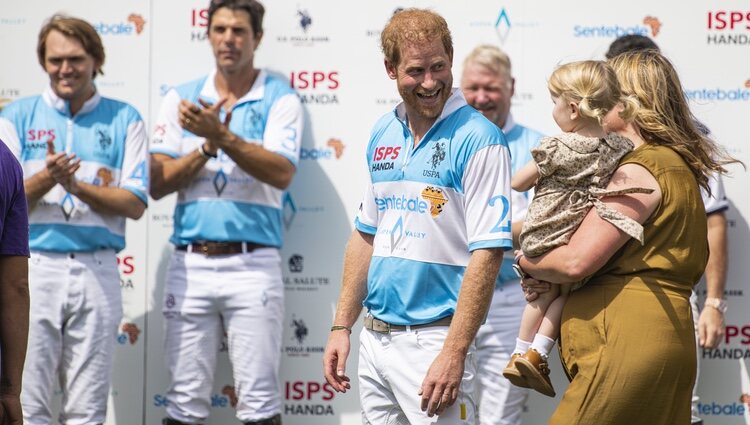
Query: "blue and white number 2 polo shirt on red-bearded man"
355 90 512 325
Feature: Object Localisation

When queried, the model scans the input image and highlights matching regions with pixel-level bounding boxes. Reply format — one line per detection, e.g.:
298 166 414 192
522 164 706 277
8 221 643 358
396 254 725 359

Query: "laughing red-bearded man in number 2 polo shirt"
323 9 512 424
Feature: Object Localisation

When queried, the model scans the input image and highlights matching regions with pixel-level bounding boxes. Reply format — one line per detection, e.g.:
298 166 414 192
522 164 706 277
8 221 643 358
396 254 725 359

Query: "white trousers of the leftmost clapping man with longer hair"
21 250 122 425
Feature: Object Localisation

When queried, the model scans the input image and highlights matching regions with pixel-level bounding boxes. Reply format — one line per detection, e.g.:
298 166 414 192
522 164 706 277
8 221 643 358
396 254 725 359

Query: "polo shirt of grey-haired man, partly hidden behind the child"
495 115 544 287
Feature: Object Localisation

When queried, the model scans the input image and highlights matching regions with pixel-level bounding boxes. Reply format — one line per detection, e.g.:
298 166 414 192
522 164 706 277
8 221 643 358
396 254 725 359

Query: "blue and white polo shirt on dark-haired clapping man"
151 70 304 247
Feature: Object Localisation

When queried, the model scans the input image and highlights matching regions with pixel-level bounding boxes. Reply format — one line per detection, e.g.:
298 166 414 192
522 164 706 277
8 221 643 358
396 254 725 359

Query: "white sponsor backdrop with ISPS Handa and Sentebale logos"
0 0 750 425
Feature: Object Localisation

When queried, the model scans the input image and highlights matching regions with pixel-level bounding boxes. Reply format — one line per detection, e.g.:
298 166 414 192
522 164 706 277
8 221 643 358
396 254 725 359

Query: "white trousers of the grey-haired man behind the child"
476 281 529 425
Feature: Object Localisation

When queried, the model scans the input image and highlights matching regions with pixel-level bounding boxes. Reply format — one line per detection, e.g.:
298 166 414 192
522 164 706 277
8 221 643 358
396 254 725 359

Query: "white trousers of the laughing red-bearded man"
358 326 476 425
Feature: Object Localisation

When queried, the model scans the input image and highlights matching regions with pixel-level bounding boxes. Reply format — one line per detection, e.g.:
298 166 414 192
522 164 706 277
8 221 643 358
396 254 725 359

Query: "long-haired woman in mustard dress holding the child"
518 51 734 425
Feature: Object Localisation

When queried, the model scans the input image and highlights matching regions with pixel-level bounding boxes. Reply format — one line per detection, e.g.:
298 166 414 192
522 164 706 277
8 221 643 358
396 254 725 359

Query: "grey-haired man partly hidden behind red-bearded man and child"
461 45 542 425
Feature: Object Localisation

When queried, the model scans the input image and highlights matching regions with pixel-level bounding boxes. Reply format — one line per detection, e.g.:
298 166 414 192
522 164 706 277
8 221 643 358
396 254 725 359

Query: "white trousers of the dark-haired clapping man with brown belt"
163 248 284 423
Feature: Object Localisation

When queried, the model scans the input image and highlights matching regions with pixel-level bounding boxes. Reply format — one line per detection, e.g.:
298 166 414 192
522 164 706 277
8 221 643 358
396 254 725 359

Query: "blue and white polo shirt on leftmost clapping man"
0 87 149 252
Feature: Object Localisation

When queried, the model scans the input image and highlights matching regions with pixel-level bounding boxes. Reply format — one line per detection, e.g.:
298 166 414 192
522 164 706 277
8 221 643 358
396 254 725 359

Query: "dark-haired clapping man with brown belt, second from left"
151 0 303 425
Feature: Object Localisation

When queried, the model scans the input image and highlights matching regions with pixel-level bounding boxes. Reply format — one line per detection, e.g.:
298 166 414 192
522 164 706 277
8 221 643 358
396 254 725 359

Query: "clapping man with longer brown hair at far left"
0 16 148 425
